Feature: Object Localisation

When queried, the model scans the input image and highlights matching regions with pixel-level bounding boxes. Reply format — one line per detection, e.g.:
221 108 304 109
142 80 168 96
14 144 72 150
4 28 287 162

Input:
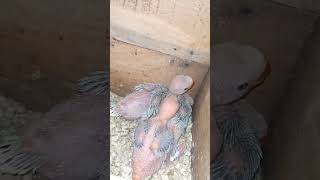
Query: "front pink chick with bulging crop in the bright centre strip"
132 76 193 180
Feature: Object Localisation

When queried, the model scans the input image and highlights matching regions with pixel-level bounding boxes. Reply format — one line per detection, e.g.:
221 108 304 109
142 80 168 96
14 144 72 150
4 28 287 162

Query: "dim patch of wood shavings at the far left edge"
0 95 43 137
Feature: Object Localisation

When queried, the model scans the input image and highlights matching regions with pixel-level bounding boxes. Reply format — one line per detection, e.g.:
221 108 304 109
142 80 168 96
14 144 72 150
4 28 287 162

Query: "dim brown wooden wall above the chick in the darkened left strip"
0 0 106 111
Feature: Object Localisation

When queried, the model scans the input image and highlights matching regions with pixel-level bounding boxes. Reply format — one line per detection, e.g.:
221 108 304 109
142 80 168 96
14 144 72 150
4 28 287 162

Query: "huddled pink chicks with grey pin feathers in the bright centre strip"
116 75 193 180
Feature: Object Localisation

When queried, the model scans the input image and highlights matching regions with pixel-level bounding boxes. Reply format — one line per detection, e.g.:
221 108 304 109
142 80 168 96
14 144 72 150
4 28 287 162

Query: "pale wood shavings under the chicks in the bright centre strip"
110 92 192 180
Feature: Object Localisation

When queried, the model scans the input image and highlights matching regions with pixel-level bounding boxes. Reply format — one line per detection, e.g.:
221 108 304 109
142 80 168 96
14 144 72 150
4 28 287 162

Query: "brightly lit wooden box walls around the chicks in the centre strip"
110 0 210 179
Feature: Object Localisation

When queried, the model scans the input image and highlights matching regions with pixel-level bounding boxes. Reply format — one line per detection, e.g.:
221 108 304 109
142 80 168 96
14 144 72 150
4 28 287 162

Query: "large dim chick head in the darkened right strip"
212 43 271 106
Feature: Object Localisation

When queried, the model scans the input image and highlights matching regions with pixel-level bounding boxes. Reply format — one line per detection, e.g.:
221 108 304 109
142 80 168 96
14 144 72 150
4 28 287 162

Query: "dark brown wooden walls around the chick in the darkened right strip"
212 0 320 180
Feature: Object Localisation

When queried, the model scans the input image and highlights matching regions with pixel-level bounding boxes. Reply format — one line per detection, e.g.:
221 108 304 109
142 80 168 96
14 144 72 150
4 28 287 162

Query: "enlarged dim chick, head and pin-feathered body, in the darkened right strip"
210 43 270 180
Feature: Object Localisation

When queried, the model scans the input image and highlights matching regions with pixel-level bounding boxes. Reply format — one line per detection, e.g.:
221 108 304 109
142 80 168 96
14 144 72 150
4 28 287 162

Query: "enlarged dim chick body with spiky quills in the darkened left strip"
0 86 109 180
